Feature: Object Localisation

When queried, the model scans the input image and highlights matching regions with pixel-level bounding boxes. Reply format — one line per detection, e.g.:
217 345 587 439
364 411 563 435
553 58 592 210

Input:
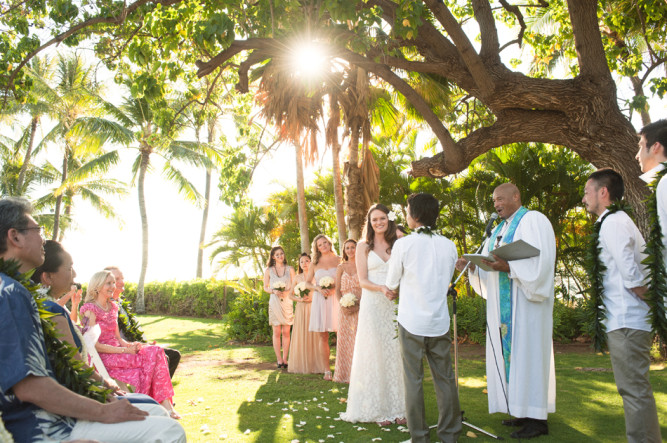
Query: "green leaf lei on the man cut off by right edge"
642 162 667 343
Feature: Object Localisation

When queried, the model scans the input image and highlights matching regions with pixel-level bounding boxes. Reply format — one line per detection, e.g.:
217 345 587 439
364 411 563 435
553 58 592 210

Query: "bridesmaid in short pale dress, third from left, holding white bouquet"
306 234 340 380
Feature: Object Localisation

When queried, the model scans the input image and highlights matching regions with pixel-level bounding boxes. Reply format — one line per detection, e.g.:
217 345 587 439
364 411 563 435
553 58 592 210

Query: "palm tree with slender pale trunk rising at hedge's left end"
104 90 218 313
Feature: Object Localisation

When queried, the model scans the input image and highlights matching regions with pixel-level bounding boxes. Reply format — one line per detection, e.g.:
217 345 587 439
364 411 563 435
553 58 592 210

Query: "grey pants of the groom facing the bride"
398 323 462 443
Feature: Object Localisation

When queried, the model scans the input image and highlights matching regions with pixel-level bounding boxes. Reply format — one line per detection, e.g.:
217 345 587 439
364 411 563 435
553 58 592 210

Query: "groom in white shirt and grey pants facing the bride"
386 193 462 443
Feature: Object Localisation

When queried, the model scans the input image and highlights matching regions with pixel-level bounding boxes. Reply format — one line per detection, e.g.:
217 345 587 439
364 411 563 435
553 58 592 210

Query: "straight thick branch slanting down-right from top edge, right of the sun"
424 0 494 98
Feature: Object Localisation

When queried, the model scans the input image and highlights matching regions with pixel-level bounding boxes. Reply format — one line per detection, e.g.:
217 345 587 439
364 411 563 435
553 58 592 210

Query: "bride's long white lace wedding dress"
341 251 405 422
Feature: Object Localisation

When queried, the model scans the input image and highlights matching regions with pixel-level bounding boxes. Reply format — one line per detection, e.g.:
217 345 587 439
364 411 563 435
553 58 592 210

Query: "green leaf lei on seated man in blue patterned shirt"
0 258 111 403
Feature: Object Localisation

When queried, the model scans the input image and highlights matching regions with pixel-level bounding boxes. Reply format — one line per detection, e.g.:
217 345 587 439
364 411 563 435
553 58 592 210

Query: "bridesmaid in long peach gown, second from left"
288 252 328 374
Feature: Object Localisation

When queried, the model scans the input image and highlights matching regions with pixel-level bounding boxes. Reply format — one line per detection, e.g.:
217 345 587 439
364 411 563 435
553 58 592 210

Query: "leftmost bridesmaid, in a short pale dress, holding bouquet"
264 246 294 369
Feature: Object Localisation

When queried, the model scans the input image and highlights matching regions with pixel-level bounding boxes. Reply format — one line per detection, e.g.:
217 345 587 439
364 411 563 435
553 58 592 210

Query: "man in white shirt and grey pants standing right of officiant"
582 169 662 443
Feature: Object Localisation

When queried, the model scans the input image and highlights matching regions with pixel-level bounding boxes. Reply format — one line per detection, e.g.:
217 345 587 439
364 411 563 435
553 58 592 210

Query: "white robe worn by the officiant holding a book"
469 211 556 420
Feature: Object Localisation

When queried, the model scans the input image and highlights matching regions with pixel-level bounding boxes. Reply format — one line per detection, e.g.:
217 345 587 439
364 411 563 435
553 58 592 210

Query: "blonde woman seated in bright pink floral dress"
81 271 181 419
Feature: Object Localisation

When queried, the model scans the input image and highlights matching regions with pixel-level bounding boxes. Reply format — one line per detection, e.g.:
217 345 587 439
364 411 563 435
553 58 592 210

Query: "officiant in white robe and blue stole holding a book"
456 183 556 439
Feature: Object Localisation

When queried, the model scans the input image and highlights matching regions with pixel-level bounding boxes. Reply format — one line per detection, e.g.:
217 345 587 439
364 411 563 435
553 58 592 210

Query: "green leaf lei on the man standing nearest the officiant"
584 200 631 352
